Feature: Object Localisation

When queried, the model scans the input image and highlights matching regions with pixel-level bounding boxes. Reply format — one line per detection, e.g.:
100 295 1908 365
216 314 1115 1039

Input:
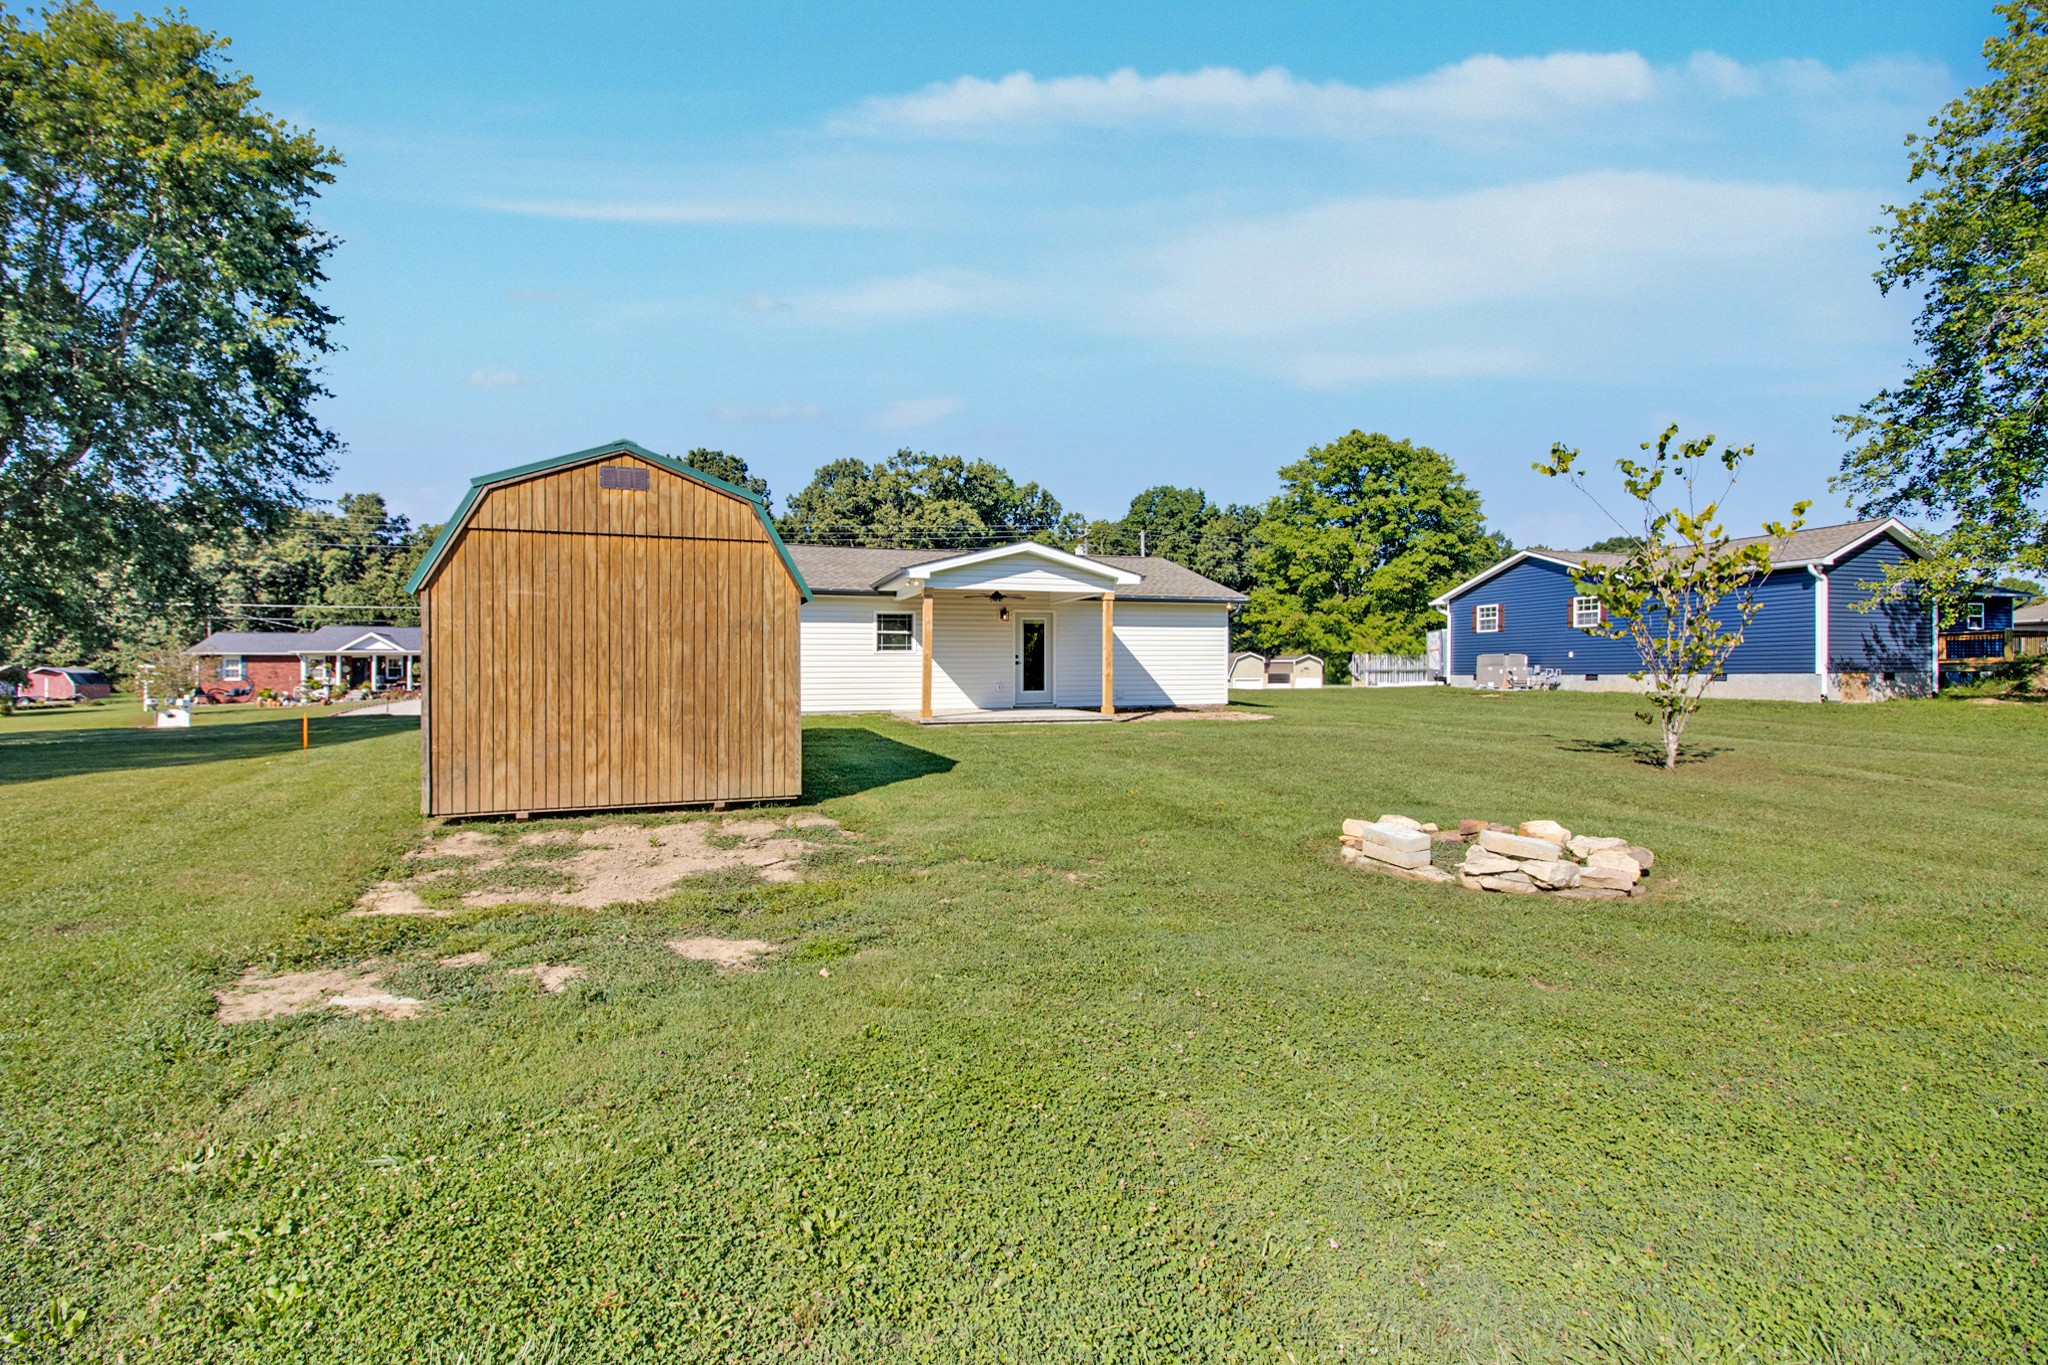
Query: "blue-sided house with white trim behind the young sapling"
1434 518 1939 702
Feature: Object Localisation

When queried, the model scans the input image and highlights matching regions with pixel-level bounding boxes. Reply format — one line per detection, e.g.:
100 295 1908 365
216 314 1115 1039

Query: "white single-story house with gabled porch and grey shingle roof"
788 542 1245 716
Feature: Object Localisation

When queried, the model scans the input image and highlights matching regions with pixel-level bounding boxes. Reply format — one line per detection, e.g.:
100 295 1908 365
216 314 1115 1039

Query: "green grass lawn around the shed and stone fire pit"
0 690 2048 1363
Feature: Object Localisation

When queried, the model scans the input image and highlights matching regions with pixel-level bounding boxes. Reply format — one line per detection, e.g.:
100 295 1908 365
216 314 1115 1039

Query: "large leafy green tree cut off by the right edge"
1837 4 2048 596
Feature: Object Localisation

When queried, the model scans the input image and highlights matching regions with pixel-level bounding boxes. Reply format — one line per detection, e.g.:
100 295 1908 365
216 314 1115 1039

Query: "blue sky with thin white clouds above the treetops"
188 0 1993 544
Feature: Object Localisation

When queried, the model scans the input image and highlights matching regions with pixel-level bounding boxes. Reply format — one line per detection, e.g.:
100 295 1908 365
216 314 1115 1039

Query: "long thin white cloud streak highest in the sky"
829 51 1944 137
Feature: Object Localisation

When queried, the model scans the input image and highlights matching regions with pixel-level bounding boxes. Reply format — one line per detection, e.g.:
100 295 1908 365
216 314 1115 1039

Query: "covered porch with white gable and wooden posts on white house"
877 544 1139 722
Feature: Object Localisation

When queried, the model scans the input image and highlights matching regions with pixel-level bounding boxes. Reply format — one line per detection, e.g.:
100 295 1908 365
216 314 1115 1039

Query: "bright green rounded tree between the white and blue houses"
1237 432 1509 677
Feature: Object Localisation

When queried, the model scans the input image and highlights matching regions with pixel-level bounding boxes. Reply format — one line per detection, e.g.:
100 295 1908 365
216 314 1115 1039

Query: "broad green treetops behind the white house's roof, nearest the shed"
778 450 1081 548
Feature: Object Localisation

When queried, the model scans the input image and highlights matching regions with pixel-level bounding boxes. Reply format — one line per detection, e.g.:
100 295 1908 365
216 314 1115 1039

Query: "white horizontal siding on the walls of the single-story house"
799 593 1231 712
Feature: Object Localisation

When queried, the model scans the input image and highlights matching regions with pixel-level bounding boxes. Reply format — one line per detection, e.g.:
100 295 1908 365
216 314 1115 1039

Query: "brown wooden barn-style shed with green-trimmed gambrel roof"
408 440 811 814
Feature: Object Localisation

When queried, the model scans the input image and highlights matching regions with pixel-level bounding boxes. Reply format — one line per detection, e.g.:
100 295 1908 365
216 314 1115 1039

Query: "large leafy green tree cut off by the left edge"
0 0 340 651
